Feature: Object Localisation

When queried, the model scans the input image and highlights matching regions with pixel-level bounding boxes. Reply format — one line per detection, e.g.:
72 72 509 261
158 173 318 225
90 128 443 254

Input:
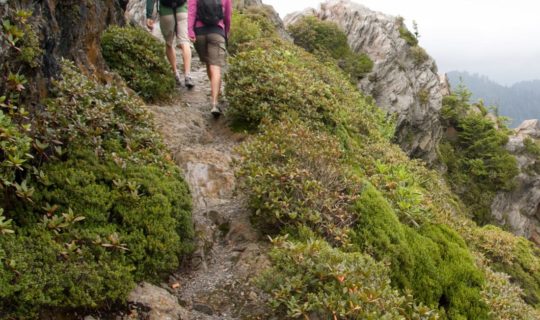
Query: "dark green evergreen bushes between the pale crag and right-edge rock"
440 88 519 224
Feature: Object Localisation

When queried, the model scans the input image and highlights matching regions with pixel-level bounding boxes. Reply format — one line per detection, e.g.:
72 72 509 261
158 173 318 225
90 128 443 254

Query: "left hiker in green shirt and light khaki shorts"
146 0 195 89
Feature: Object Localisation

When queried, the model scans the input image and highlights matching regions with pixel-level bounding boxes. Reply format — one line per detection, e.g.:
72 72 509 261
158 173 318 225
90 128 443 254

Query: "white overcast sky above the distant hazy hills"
263 0 540 85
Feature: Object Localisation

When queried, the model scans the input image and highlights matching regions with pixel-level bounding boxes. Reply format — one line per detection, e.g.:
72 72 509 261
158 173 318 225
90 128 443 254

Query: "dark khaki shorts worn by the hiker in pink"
195 33 227 67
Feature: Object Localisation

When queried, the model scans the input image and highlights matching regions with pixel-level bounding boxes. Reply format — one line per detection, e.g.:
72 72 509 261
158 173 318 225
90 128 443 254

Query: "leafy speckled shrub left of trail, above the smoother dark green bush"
41 61 167 163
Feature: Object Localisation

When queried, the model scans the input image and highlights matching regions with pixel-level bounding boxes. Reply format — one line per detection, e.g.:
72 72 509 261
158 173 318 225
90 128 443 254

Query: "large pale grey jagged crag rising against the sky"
285 0 443 163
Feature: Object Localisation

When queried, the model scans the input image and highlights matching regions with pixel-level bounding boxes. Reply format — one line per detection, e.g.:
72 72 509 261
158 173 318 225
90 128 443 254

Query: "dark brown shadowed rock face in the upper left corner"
0 0 124 102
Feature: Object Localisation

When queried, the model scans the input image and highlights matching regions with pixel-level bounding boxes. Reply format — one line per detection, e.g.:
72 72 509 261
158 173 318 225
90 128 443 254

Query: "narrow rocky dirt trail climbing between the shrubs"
124 57 268 320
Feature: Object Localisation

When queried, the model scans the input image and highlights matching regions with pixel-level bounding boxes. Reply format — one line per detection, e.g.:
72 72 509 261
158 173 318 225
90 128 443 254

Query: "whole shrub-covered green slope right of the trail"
226 10 540 319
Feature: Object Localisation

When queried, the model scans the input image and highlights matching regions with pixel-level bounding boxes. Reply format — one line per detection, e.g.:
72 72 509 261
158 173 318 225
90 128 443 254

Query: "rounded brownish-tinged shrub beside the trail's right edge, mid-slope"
237 119 355 241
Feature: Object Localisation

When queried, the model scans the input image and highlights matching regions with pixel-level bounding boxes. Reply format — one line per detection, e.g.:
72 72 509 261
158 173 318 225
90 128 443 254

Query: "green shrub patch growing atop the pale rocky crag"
288 16 373 82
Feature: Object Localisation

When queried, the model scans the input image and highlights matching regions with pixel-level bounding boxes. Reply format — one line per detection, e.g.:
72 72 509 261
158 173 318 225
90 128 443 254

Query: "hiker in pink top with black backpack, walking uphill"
188 0 232 117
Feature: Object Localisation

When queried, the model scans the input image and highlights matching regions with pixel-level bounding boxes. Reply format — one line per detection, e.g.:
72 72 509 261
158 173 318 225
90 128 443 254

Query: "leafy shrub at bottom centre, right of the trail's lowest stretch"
261 239 438 320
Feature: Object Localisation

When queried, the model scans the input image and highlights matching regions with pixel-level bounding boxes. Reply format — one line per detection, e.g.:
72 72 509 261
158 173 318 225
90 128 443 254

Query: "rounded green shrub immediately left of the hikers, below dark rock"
101 26 175 101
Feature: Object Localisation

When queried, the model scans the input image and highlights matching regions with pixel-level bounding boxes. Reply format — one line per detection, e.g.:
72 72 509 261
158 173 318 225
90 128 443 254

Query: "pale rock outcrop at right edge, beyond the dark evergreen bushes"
491 120 540 245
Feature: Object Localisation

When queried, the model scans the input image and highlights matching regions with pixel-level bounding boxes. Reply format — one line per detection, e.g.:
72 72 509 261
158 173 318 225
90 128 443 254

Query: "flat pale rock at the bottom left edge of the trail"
128 282 191 320
